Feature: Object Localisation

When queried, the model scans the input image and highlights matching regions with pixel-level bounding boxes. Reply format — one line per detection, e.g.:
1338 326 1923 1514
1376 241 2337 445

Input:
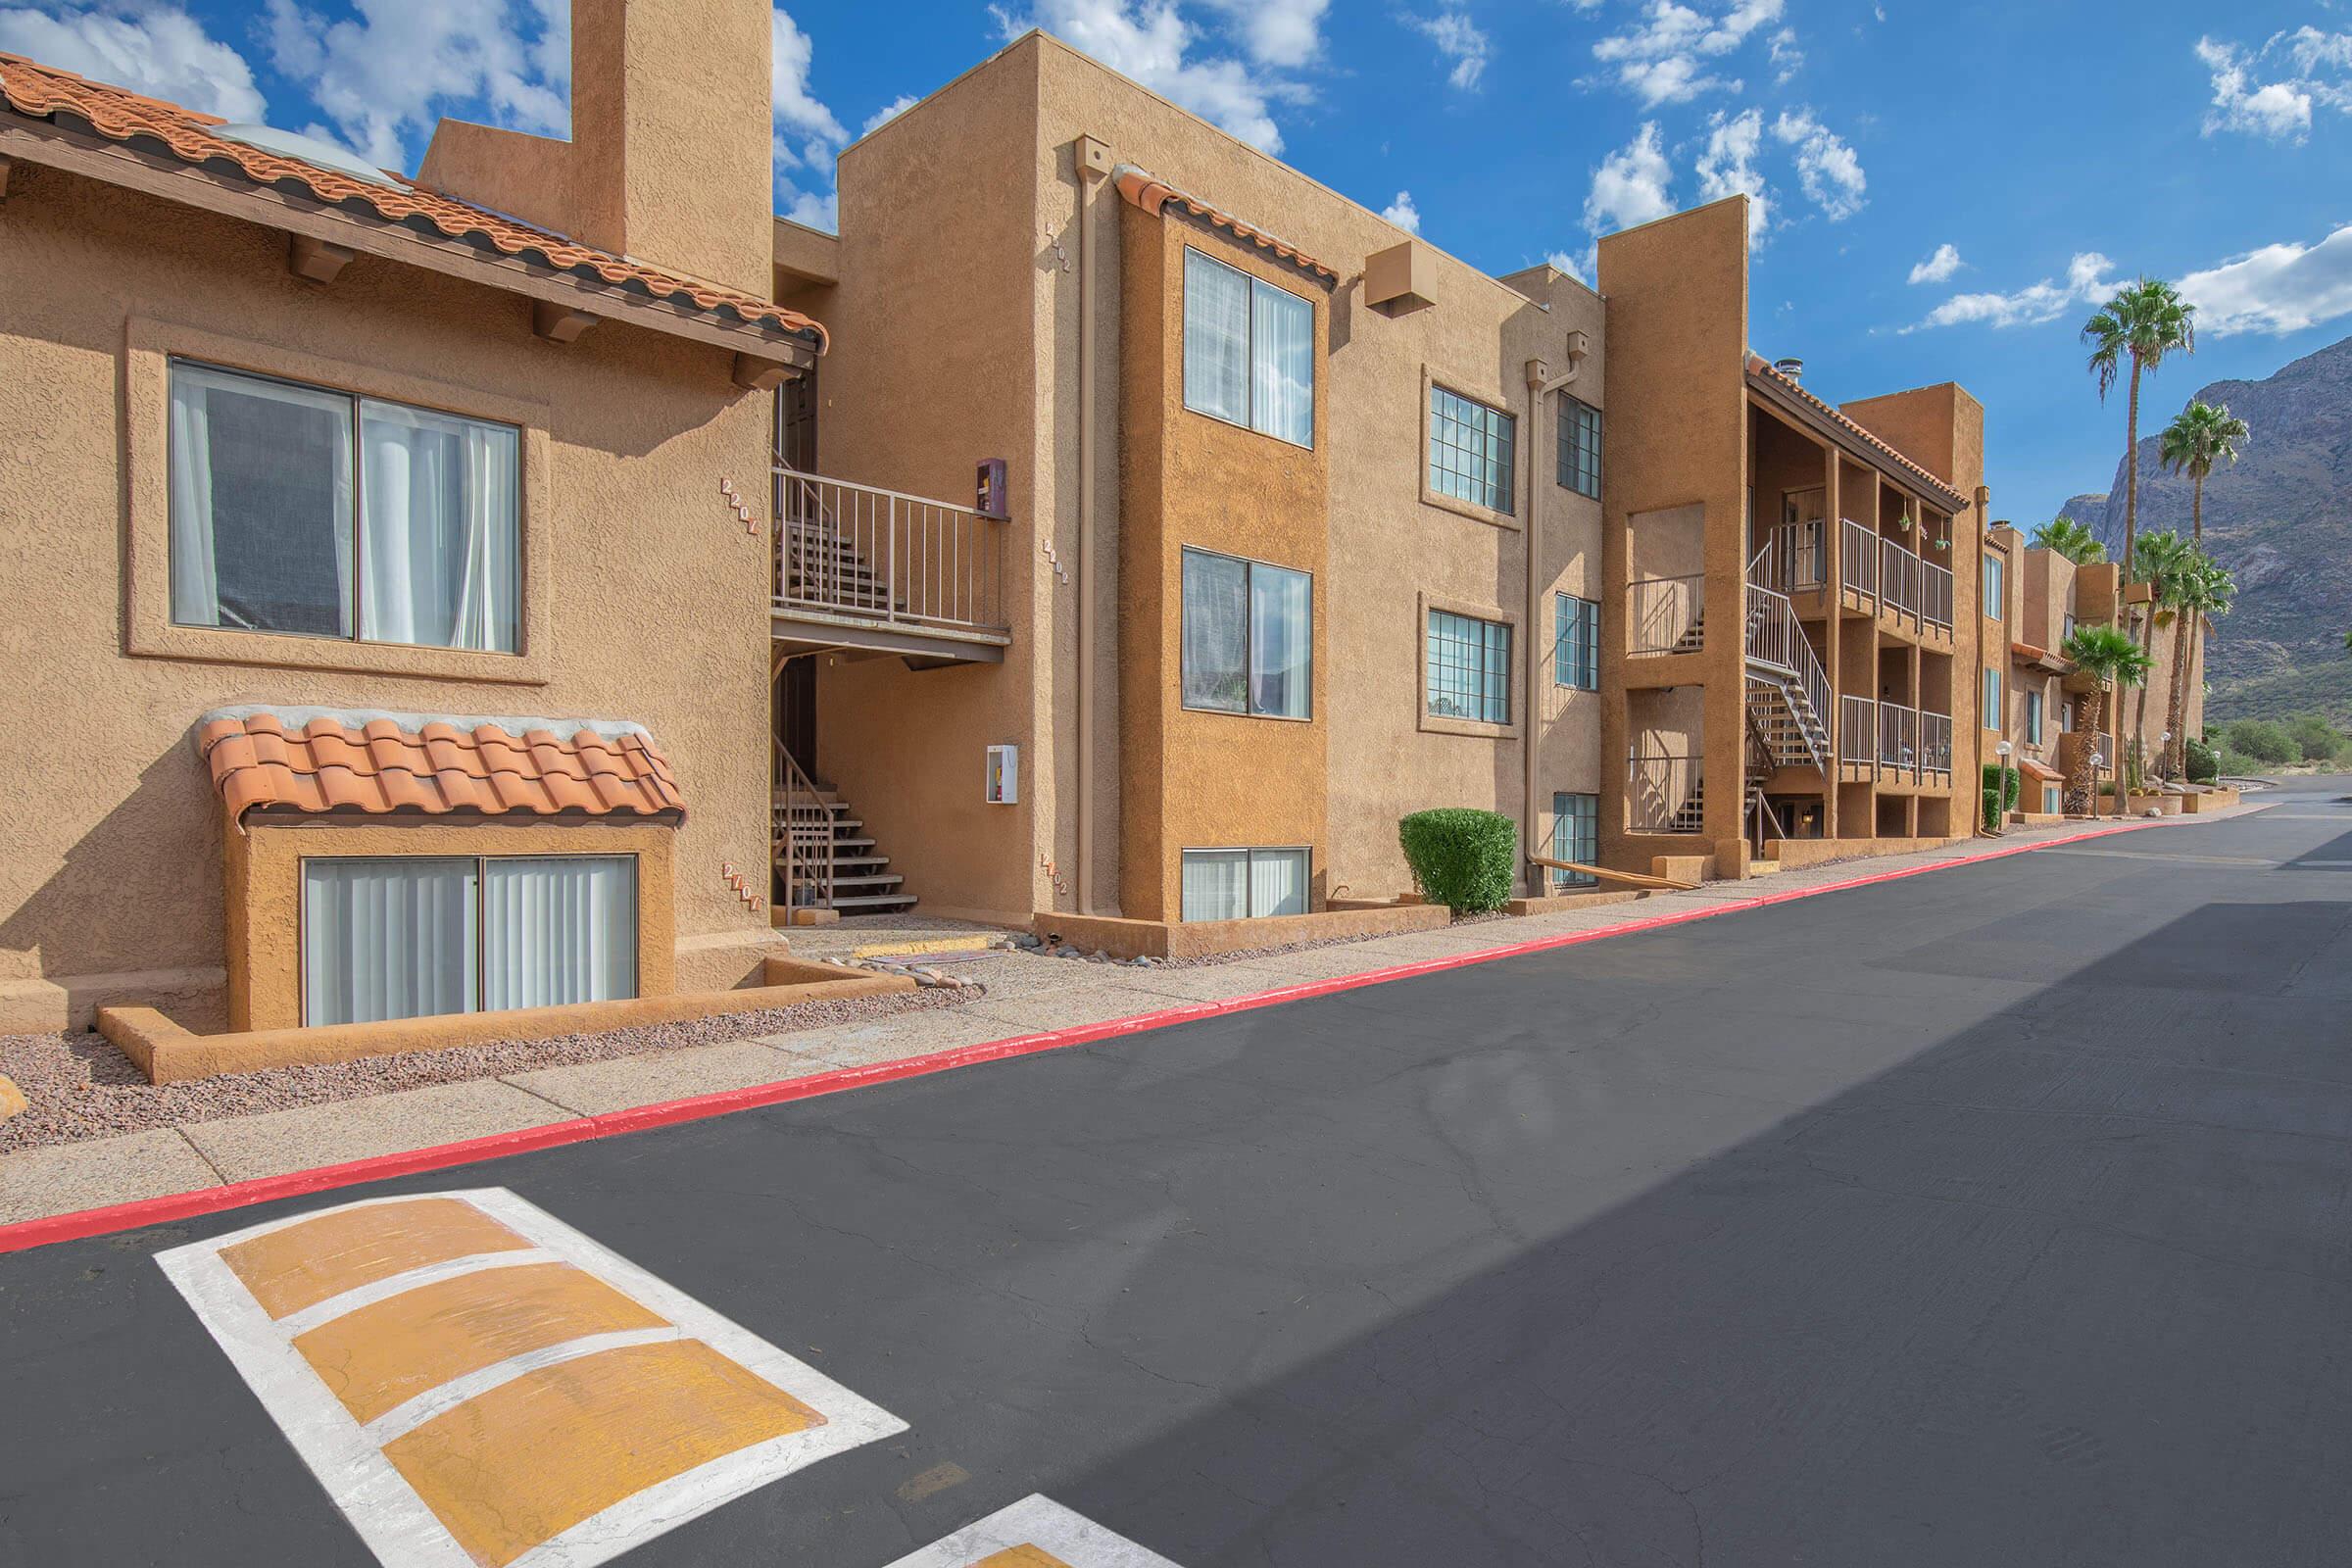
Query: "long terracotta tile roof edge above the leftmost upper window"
0 54 825 346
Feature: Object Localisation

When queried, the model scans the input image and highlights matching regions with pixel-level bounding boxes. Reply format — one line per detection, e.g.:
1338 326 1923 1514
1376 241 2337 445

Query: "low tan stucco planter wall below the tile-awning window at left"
99 956 915 1084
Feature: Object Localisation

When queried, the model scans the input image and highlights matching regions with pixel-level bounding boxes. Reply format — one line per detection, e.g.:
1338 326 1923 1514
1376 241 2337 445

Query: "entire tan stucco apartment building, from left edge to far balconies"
0 12 2023 1053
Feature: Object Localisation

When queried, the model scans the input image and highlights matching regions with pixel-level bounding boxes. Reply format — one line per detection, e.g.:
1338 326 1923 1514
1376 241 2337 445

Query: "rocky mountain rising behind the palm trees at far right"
2063 338 2352 724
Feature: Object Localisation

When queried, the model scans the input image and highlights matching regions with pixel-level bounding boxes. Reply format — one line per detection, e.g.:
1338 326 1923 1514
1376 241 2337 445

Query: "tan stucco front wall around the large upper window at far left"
0 163 774 1027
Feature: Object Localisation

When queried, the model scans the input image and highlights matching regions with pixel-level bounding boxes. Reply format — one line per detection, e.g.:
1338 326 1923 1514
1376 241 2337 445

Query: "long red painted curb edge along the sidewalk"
0 818 2176 1253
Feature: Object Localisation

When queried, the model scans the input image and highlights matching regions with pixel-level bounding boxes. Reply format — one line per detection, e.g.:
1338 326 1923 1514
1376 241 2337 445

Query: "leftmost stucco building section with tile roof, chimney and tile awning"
0 0 825 1030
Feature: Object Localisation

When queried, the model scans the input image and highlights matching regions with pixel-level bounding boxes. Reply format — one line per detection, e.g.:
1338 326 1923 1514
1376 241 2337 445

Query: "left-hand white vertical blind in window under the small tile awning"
301 858 477 1022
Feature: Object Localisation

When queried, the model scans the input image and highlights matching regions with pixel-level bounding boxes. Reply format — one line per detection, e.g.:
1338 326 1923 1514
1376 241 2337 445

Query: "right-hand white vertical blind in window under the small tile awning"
482 856 637 1010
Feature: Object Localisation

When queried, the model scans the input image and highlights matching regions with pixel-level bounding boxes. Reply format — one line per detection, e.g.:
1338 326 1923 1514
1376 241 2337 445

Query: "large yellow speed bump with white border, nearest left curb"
158 1187 906 1568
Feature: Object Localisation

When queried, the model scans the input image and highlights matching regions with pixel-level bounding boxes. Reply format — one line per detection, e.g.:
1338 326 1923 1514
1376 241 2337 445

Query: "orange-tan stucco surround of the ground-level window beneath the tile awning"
223 813 677 1030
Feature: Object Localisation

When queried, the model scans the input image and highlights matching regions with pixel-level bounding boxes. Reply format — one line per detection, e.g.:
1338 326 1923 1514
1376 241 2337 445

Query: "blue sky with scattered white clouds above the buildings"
0 0 2352 522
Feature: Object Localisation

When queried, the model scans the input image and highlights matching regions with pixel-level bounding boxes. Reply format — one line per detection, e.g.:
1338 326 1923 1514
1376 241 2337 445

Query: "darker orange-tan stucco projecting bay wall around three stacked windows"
1119 202 1331 921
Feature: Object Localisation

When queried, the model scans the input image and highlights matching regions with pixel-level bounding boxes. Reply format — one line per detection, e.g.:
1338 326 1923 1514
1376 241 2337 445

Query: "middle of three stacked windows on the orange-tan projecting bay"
1183 550 1315 719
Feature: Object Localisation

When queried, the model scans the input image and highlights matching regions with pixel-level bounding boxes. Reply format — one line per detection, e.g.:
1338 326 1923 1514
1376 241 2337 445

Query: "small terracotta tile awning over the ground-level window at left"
195 708 687 823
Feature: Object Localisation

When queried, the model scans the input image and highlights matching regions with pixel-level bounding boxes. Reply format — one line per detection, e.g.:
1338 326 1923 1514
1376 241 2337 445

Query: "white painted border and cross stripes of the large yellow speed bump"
155 1187 907 1568
